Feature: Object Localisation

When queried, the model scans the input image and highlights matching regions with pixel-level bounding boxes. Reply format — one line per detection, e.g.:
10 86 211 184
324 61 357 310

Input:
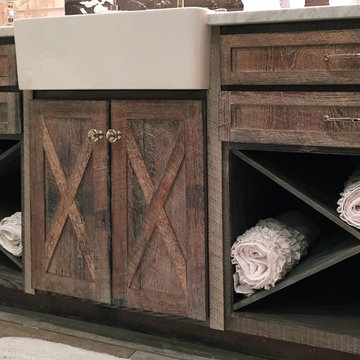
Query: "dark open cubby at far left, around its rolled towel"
0 139 23 288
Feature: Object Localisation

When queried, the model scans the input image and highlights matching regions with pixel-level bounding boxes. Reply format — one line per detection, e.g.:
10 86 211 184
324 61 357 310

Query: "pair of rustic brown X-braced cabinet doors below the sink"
30 100 206 320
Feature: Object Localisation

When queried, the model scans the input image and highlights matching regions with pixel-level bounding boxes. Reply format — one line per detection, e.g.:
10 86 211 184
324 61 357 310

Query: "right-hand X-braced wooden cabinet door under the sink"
111 101 206 320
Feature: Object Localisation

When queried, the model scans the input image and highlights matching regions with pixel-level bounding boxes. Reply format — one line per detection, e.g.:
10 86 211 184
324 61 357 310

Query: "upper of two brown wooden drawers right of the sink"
221 29 360 85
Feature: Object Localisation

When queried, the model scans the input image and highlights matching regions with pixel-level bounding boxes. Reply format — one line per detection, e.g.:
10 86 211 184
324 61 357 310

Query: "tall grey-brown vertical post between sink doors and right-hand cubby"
207 27 225 330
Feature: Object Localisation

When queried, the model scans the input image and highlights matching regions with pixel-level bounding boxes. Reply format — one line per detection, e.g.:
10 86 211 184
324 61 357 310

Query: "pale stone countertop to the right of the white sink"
207 5 360 26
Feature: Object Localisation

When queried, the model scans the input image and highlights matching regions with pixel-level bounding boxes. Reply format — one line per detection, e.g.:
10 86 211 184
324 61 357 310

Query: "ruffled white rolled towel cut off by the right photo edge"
337 171 360 229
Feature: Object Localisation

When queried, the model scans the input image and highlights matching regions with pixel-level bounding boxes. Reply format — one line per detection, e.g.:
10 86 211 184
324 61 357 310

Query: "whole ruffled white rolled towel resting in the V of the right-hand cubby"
231 211 319 296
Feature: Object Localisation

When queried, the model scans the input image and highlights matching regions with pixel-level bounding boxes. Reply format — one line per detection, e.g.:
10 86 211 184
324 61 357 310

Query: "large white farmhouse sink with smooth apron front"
14 8 210 90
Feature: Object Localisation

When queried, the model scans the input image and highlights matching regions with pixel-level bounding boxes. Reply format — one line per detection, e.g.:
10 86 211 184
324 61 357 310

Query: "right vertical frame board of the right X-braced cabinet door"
185 101 208 320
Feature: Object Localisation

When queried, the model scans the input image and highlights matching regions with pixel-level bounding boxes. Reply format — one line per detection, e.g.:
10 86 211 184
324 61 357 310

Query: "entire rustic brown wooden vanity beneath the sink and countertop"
0 9 360 360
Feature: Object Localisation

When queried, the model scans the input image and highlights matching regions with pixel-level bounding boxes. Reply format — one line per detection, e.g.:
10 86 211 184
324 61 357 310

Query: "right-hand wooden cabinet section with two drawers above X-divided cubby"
218 22 360 355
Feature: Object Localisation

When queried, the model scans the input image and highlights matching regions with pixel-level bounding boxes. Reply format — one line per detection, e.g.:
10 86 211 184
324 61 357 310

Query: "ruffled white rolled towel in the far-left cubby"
0 212 22 256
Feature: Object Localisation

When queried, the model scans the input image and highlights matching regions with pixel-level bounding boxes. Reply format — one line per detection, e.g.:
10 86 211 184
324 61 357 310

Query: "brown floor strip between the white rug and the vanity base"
0 306 264 360
